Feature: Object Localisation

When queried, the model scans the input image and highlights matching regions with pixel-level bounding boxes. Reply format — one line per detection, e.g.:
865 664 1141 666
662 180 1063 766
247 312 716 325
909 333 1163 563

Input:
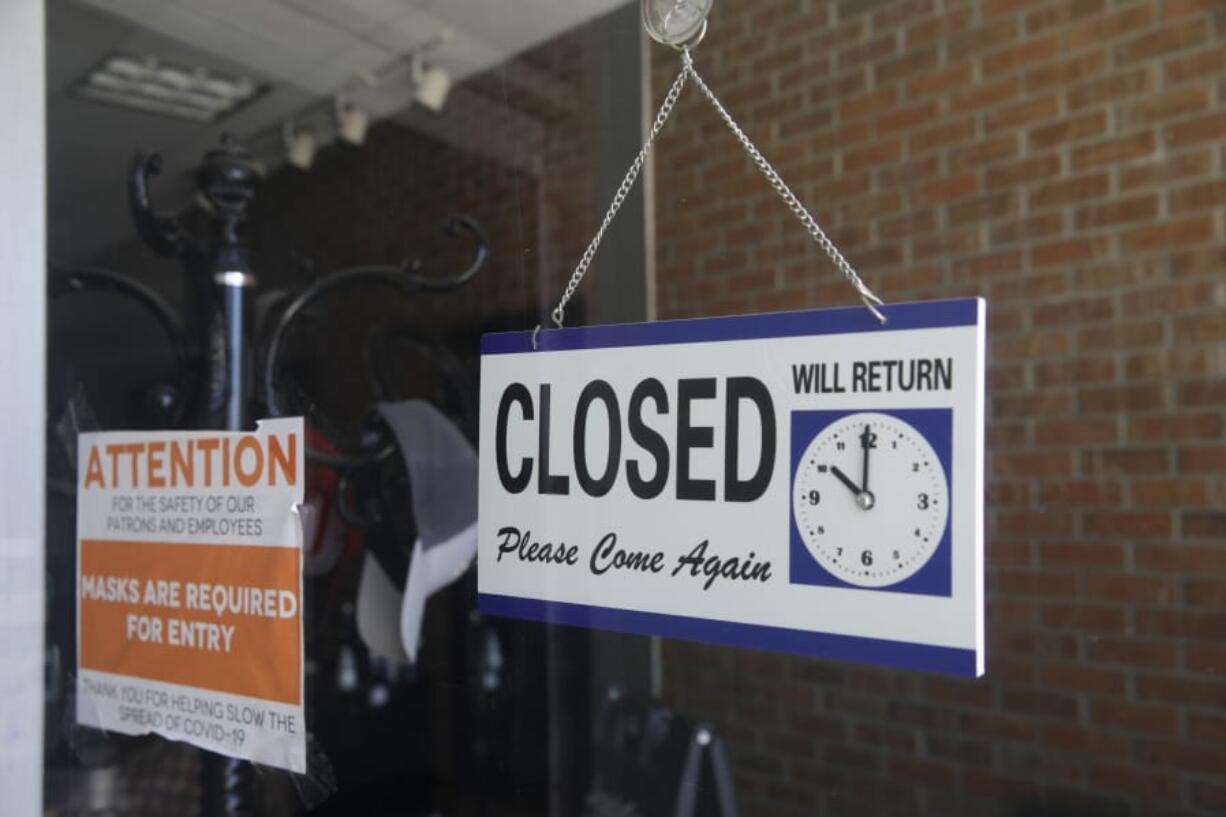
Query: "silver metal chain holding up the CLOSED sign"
532 48 885 348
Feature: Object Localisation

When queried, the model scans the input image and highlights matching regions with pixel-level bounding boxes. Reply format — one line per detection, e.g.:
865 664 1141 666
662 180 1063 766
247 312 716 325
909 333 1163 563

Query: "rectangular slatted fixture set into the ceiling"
72 54 267 123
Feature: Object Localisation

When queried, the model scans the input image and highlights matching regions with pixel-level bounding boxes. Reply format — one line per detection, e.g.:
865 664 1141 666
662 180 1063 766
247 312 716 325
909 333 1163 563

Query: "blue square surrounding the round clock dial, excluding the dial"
787 409 954 596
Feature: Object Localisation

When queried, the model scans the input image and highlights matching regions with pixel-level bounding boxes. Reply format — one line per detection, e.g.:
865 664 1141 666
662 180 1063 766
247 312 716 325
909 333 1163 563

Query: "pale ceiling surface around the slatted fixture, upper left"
47 0 628 261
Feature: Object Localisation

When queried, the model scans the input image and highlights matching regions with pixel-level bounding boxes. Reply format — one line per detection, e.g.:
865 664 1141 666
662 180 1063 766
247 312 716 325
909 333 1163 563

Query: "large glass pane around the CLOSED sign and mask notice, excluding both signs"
38 0 1226 817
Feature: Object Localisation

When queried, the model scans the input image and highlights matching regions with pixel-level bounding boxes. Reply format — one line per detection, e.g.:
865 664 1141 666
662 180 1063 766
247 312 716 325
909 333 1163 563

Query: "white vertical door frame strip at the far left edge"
0 0 47 817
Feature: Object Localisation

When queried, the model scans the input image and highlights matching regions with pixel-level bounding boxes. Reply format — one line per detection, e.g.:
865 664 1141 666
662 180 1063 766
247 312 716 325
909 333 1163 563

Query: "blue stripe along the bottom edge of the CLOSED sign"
477 593 978 678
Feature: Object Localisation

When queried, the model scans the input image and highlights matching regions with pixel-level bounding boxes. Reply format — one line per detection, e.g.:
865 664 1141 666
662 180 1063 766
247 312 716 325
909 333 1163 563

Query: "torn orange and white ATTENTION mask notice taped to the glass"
77 417 307 772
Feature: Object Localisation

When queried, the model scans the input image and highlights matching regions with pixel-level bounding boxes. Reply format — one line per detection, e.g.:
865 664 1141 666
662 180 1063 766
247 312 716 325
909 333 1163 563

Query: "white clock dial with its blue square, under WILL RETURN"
791 410 950 595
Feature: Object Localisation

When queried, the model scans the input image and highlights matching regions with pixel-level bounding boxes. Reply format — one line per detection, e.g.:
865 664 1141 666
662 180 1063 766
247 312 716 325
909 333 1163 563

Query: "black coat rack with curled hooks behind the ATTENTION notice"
50 135 489 817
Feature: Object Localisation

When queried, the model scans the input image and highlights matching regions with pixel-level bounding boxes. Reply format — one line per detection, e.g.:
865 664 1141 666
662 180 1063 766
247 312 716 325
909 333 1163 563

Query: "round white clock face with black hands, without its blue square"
792 412 949 588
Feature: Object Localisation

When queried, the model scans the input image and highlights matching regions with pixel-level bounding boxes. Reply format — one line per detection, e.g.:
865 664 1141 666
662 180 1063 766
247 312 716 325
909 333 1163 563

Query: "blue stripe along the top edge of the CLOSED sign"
481 298 982 355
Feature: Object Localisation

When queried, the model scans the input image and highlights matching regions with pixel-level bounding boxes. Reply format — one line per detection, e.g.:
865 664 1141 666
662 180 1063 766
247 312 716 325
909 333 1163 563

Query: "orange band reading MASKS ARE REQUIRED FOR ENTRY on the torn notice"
80 539 302 704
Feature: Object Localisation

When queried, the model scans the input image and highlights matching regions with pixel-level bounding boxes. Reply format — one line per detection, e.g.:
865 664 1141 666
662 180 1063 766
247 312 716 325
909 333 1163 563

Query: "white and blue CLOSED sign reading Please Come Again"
478 298 984 676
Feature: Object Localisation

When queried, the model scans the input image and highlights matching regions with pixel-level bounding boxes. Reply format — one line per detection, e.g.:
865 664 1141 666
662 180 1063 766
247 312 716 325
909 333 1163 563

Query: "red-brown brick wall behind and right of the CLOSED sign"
652 0 1226 817
